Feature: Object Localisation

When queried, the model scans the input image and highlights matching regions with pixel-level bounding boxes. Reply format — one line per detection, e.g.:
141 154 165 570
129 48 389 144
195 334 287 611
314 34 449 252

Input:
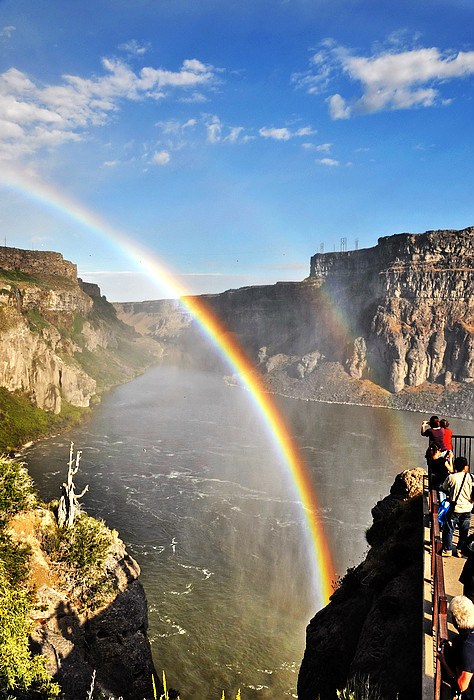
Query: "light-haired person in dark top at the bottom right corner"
439 595 474 700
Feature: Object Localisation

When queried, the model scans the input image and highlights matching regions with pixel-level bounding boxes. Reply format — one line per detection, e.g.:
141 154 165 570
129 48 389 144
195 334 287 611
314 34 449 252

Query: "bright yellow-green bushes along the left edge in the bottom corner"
0 457 60 700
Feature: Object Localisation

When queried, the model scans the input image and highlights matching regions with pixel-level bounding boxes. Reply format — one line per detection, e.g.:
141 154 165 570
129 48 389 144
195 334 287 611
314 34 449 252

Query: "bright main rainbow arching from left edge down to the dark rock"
0 170 334 604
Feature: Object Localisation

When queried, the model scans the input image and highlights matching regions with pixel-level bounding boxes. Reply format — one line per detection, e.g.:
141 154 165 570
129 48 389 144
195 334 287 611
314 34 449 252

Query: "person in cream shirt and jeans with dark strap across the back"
441 457 472 557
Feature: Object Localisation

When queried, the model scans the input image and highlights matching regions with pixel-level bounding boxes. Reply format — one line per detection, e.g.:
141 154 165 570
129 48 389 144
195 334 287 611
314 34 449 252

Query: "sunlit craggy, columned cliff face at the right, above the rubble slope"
310 227 474 393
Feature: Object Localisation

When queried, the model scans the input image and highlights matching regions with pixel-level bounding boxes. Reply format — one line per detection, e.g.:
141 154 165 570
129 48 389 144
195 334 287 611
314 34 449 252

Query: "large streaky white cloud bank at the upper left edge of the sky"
0 57 217 159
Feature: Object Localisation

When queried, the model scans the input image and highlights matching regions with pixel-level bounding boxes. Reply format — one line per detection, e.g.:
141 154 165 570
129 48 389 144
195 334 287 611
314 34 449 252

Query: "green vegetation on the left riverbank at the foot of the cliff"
0 387 90 453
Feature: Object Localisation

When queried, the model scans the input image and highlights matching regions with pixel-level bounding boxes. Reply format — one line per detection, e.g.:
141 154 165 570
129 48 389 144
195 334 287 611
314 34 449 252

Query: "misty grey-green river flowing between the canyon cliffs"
24 366 473 700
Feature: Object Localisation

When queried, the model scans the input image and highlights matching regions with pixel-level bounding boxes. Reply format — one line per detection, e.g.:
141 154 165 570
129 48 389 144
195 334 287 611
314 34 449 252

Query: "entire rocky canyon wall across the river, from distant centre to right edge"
116 227 474 416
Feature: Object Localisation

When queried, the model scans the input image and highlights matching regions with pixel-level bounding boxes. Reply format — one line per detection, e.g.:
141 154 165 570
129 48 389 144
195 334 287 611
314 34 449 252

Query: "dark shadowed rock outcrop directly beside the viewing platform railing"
298 468 425 700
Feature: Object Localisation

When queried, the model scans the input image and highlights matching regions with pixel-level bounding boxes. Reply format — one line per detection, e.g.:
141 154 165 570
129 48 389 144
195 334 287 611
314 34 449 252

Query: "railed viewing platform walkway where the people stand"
422 435 474 700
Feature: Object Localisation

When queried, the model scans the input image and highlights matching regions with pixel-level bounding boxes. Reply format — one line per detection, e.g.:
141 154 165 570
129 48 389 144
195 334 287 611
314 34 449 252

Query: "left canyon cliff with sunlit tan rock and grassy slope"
0 247 159 413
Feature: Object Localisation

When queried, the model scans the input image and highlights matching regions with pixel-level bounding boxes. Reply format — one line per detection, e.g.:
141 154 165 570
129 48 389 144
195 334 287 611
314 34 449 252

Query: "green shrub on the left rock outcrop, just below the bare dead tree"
43 513 114 610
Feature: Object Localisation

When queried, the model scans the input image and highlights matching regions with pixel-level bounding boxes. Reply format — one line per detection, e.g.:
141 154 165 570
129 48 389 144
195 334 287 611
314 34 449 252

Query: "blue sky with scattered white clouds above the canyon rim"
0 0 474 301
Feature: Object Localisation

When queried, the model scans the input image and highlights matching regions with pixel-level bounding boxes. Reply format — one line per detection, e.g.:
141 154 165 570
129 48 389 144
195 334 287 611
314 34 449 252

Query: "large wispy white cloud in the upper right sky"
292 35 474 119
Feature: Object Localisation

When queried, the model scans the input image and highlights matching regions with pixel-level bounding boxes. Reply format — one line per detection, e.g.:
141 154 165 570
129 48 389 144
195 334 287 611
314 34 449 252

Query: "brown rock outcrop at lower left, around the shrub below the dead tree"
9 509 155 700
